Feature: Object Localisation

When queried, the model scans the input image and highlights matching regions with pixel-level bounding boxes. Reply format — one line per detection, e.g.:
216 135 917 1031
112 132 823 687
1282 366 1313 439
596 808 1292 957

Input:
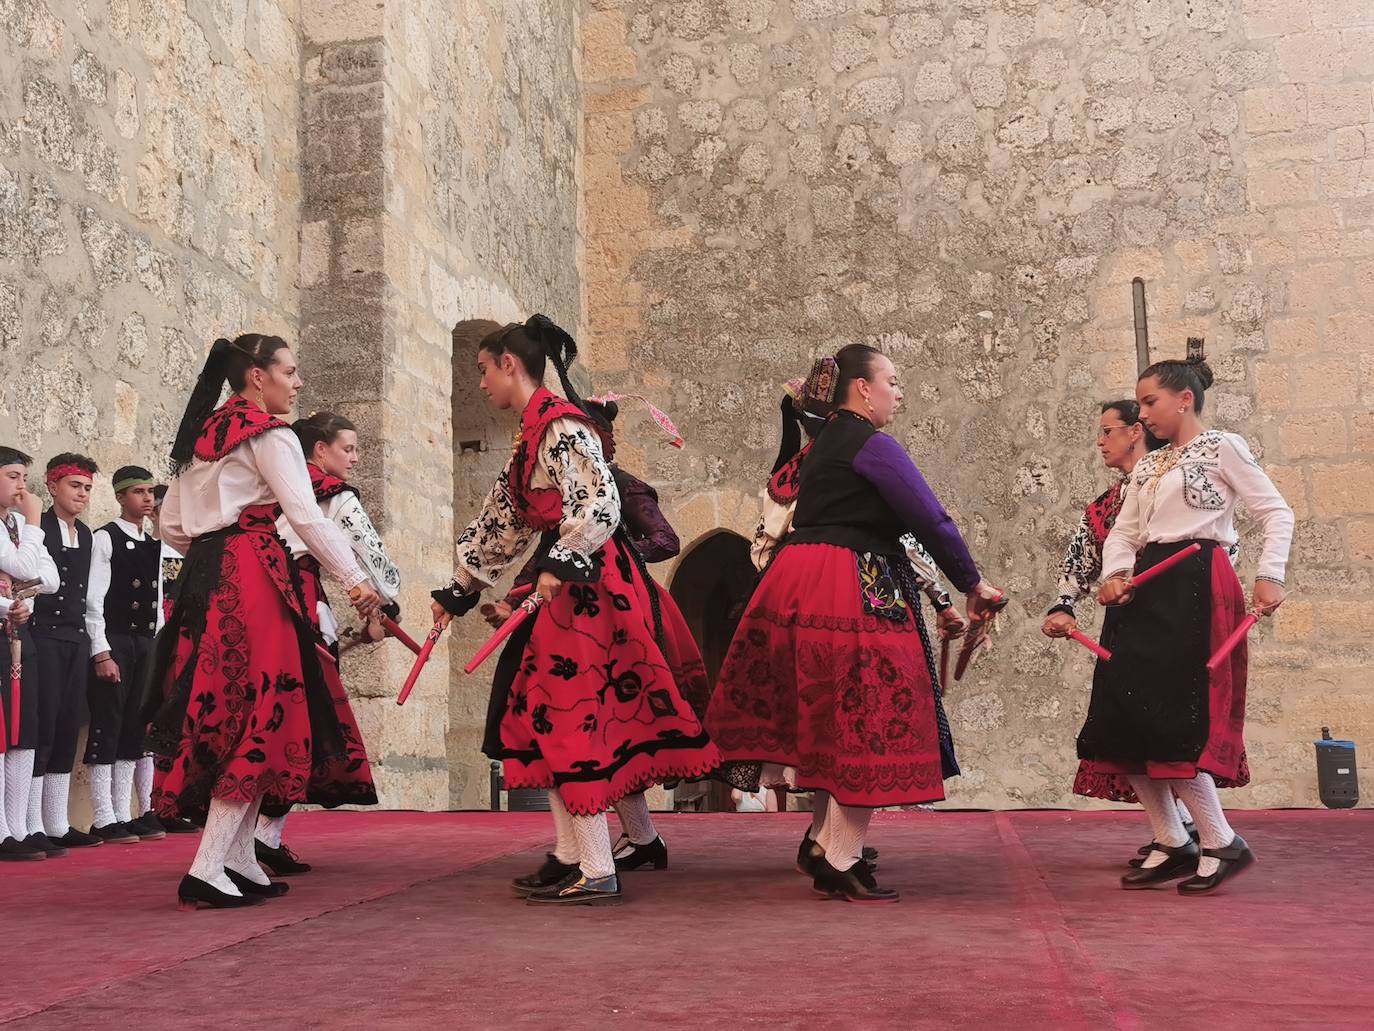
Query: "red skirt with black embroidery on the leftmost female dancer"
148 506 376 817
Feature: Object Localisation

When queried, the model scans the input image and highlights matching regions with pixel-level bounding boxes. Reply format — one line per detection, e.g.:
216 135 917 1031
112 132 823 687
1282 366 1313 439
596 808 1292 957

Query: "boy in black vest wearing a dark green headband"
84 466 166 844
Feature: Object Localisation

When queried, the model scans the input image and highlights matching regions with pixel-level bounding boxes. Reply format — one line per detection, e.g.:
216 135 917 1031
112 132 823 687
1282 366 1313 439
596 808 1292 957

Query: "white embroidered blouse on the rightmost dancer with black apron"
1102 430 1293 584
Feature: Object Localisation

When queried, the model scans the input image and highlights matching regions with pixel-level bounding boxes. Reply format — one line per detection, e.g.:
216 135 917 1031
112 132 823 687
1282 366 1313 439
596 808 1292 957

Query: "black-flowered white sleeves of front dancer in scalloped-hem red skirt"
444 418 620 595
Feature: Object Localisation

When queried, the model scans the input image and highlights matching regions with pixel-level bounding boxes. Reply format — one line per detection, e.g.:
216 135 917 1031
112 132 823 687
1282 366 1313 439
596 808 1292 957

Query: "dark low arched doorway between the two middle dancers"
668 529 758 812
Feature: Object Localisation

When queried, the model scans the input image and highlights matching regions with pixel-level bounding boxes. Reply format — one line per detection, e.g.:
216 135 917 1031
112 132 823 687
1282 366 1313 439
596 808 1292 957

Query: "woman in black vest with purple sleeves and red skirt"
706 344 1002 902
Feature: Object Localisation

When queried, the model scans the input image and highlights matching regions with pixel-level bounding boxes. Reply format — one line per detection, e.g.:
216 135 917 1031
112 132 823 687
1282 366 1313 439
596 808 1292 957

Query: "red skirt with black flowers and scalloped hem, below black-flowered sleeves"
482 535 720 815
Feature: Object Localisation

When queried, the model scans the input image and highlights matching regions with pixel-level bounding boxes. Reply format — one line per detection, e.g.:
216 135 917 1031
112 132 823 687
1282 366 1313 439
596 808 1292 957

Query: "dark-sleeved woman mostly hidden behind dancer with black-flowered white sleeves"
481 401 710 873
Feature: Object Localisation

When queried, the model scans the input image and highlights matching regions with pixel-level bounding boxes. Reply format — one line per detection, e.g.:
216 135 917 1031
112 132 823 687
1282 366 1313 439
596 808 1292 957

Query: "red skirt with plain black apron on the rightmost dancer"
1074 540 1250 801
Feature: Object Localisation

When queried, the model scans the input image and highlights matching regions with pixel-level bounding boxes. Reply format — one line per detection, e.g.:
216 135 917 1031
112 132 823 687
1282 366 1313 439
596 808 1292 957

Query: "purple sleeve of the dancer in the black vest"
853 433 981 594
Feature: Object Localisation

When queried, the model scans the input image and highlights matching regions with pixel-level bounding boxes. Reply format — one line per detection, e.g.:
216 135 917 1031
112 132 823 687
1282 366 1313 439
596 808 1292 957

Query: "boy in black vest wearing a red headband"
29 452 100 848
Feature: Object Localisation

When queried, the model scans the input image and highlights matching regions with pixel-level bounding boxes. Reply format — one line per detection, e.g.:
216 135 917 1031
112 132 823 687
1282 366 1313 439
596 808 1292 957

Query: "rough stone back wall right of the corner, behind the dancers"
583 0 1374 807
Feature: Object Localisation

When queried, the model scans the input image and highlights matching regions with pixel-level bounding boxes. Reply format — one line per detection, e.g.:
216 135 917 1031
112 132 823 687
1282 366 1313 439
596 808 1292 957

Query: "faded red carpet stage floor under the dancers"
0 811 1374 1031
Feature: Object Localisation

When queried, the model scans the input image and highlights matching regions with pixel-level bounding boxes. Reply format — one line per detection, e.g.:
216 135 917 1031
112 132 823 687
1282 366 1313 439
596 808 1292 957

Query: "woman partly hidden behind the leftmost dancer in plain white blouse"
253 411 401 877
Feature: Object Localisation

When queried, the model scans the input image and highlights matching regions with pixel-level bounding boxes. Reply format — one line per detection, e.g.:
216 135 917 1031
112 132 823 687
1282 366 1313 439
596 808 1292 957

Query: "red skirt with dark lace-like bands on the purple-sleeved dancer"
706 544 952 807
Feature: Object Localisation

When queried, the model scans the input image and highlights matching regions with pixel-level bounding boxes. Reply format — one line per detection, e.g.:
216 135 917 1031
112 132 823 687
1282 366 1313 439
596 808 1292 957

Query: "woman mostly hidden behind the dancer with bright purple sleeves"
750 379 966 877
